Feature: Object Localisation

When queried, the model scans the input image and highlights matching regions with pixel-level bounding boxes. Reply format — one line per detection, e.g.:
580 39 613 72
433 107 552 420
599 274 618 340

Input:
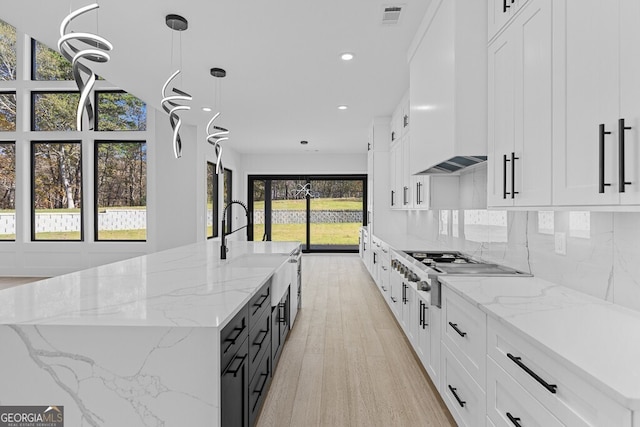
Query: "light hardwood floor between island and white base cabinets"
257 255 456 427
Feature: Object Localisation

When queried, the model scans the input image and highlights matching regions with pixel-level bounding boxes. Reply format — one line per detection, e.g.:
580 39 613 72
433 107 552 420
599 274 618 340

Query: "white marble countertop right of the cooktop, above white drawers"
441 276 640 410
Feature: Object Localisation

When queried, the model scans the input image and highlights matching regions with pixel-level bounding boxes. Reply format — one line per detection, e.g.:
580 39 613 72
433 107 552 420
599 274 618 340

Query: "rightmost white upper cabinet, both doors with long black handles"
553 0 640 206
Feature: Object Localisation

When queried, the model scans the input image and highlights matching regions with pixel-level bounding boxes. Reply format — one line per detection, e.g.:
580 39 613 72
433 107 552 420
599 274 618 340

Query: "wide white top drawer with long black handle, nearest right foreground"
487 318 632 427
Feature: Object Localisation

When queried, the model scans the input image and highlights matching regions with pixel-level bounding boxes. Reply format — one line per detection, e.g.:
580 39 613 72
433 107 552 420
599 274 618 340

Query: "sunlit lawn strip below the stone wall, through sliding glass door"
253 222 362 245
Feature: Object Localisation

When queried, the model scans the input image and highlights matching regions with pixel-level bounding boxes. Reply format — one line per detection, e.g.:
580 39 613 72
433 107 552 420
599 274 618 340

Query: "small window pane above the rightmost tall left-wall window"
96 91 147 131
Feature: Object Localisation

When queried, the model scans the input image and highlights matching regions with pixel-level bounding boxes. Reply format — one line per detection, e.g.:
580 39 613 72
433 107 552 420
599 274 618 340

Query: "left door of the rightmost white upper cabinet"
553 0 620 206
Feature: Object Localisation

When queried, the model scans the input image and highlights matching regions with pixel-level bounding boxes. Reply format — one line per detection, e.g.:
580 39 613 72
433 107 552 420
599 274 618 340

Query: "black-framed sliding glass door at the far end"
249 175 366 252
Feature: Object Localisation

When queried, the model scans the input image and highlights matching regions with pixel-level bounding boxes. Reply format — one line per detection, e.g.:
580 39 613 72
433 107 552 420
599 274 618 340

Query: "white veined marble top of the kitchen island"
0 240 300 327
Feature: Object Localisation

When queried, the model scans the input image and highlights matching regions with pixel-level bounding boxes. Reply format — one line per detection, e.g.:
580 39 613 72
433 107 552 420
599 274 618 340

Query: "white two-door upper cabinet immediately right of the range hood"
487 0 552 207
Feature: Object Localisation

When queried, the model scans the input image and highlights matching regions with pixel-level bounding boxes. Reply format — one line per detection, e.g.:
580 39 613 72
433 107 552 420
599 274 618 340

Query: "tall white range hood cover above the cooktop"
409 0 487 175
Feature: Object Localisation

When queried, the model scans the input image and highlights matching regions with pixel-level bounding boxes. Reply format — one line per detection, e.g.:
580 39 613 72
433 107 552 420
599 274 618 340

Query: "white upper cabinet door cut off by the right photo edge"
617 0 640 204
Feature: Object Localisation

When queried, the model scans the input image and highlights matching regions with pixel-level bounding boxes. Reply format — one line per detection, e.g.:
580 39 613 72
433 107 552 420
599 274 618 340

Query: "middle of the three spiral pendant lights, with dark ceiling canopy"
160 14 193 159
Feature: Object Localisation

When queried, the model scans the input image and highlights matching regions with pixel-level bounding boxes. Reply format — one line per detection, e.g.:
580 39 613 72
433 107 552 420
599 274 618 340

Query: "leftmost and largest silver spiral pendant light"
58 3 113 130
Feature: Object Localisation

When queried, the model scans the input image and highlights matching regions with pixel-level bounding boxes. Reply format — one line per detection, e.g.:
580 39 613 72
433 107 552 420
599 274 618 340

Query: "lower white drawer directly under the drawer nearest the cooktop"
440 345 486 427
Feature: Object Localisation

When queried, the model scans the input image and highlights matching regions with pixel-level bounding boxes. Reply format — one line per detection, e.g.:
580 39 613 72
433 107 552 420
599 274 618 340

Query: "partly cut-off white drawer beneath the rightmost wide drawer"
487 357 563 427
